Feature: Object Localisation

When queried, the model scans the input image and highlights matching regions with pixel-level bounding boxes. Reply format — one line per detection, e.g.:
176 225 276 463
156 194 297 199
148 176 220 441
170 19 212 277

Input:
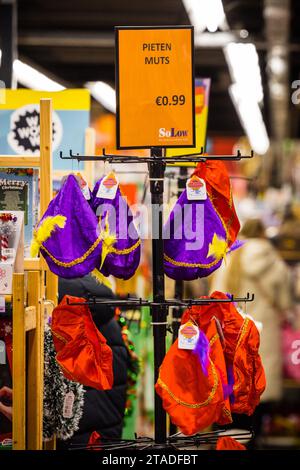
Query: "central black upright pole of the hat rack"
149 147 168 444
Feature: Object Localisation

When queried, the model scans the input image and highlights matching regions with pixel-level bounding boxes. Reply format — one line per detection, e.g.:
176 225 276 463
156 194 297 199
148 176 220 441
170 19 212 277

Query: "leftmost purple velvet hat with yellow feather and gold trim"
31 175 109 278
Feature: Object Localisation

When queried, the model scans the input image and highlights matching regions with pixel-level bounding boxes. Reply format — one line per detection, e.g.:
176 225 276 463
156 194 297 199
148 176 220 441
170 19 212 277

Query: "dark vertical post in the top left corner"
0 0 17 88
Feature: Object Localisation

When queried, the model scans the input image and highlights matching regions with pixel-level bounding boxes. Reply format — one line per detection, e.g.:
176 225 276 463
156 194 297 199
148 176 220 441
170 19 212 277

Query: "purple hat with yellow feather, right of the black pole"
163 190 228 281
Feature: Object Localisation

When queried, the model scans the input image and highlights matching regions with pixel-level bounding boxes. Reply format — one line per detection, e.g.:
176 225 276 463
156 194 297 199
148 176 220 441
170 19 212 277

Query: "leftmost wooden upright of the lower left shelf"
12 274 26 450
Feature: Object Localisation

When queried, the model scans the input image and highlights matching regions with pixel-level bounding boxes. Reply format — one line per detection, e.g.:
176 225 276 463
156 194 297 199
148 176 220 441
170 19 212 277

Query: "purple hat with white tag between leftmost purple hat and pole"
91 173 141 279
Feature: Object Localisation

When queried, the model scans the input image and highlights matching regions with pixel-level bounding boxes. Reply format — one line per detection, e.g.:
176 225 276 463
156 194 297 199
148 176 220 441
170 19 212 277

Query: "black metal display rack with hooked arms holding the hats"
60 147 254 449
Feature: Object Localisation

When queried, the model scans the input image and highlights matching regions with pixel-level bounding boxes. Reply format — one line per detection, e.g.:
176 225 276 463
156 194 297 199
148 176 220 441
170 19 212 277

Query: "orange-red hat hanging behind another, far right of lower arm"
182 292 266 415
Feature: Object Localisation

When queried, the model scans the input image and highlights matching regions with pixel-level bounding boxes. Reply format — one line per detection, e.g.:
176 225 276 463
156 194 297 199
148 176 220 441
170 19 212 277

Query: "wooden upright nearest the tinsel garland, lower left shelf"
27 271 44 450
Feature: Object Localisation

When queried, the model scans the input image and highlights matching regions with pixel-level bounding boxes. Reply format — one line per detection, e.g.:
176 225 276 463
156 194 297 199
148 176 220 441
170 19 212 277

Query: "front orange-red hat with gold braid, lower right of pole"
155 321 231 435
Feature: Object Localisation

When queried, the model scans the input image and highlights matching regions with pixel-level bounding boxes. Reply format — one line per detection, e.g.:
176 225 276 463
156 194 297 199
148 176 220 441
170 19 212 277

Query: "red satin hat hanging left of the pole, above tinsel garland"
51 295 113 390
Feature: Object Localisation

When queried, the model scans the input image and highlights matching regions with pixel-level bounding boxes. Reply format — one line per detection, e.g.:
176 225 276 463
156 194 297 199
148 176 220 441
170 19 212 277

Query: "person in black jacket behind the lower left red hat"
58 275 129 448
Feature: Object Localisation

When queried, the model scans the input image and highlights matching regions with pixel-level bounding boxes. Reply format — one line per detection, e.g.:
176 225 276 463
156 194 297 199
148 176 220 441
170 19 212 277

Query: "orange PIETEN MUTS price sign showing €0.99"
116 26 195 149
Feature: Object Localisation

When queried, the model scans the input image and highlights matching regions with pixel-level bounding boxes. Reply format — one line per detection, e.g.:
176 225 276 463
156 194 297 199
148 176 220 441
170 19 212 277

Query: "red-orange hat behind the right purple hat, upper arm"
194 160 240 247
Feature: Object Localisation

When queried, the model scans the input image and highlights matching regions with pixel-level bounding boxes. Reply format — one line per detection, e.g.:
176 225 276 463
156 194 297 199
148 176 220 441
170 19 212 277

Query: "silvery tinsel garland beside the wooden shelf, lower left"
43 325 84 441
